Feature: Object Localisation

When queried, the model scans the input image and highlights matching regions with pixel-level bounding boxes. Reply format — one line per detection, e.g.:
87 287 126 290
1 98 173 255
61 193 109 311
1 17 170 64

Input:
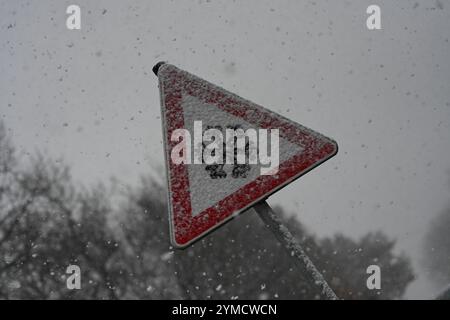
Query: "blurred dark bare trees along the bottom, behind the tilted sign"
0 123 413 299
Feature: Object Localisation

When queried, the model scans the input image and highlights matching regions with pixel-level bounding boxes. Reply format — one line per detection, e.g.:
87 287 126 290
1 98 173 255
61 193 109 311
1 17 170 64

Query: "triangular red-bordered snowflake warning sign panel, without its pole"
154 63 337 247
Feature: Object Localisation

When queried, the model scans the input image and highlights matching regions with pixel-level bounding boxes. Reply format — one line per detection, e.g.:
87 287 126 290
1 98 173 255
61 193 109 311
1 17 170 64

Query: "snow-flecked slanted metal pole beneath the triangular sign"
253 201 339 300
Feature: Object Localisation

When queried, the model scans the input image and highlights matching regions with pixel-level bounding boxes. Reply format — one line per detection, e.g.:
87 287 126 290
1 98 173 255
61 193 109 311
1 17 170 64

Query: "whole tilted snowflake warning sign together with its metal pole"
153 62 337 299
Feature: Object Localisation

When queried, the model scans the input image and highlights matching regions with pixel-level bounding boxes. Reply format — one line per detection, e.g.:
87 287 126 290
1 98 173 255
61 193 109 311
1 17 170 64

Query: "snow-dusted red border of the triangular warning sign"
155 64 338 248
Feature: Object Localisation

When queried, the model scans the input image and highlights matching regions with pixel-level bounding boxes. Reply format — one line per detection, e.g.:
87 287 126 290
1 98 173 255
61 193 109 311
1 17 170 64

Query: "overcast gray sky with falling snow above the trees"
0 0 450 298
